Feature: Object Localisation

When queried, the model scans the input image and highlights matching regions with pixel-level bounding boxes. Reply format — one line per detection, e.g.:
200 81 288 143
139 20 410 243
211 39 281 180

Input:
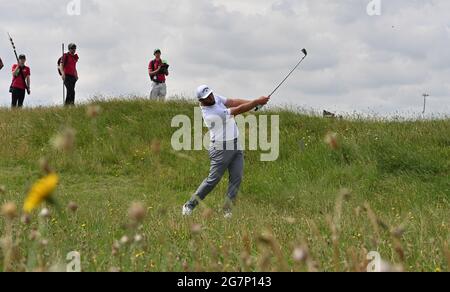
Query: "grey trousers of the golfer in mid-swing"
187 139 244 209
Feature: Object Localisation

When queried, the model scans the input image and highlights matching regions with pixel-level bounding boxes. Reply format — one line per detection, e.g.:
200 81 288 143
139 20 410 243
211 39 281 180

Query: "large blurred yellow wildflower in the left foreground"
23 173 59 213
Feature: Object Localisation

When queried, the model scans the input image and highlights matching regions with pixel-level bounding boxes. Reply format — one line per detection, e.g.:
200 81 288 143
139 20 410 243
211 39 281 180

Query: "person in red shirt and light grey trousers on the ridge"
148 49 169 101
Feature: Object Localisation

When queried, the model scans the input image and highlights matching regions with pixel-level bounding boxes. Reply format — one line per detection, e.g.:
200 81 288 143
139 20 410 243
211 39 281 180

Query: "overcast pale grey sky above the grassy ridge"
0 0 450 115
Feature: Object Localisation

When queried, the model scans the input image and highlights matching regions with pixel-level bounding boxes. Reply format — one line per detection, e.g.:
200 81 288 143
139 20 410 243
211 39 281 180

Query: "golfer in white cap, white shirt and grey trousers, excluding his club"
182 85 270 218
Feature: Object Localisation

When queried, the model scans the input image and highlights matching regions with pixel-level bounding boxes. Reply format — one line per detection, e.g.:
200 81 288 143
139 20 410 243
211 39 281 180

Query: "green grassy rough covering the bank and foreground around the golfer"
0 100 450 271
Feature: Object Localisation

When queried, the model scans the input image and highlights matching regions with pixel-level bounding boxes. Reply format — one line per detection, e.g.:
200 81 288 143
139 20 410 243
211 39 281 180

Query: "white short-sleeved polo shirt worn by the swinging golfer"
201 94 239 142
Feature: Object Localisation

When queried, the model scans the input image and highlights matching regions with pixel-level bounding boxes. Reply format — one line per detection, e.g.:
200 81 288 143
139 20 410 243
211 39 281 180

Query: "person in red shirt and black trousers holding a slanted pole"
11 55 31 108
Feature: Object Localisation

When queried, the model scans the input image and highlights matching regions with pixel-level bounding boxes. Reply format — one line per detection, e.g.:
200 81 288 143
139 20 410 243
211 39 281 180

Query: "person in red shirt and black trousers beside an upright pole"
59 44 79 106
